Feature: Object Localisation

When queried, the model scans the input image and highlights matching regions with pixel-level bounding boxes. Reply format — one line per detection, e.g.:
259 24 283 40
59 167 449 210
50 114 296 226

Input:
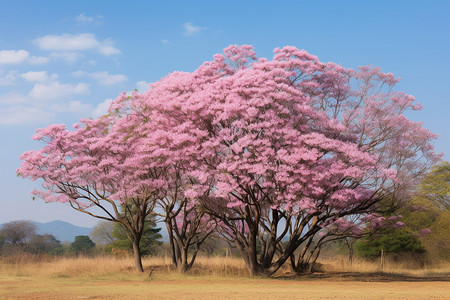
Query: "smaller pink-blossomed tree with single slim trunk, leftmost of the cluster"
17 107 164 272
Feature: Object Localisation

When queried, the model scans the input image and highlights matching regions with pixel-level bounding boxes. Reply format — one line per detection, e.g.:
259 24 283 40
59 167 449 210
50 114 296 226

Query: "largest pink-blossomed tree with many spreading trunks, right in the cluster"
120 46 438 275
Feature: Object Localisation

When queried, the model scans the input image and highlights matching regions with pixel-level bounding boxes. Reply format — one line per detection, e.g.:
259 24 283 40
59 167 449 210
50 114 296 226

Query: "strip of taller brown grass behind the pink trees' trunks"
0 253 450 277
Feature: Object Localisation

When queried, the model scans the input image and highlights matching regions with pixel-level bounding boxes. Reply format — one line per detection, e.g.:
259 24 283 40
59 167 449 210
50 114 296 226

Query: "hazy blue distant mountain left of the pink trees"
33 220 92 242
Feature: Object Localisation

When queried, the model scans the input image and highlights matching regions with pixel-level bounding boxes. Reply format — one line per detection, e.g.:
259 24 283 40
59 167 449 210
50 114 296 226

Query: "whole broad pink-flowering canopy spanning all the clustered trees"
18 45 439 275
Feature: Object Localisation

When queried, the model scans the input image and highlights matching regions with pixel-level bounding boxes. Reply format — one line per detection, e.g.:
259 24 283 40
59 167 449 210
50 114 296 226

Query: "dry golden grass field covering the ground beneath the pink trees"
0 256 450 299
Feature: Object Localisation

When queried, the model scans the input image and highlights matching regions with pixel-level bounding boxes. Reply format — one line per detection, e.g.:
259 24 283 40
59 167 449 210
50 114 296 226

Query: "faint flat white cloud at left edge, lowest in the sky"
0 106 54 125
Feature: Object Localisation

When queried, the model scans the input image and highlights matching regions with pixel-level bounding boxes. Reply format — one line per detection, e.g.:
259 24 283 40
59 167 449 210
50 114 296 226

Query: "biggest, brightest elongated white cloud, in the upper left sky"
35 33 120 55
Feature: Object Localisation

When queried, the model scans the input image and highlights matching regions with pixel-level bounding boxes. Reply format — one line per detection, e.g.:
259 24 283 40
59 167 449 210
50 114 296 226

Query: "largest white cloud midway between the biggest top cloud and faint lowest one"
28 81 89 100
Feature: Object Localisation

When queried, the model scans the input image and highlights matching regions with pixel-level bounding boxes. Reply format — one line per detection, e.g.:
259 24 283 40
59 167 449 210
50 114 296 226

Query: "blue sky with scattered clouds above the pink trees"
0 0 450 226
